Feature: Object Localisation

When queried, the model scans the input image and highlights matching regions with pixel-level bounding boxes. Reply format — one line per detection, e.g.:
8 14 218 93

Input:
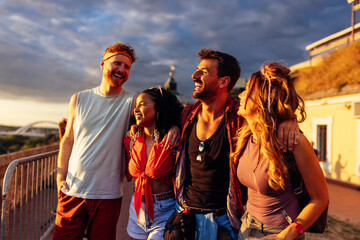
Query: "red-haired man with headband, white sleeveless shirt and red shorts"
53 42 136 240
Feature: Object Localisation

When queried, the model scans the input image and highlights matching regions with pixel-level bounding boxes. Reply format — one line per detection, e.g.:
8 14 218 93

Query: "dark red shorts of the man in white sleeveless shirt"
53 191 122 240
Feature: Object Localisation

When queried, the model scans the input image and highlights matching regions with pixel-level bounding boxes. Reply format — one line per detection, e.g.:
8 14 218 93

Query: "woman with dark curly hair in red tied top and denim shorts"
124 87 182 240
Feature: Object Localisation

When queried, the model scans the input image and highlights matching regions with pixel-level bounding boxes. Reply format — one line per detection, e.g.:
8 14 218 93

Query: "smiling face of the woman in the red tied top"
134 93 156 129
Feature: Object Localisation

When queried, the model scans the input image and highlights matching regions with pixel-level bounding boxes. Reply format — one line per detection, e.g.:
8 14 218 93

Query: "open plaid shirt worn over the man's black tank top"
175 97 247 232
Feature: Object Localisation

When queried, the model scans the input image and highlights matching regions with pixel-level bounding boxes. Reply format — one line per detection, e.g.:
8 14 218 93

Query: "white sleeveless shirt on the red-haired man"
62 87 134 199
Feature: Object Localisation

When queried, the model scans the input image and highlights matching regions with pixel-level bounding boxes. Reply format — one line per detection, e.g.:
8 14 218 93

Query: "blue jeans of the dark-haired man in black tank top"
175 202 237 240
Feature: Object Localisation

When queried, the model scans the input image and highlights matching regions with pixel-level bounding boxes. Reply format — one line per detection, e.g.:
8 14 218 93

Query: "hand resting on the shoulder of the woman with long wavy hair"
277 120 300 152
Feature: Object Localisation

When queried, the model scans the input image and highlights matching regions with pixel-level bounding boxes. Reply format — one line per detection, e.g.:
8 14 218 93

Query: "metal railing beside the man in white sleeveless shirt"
1 150 59 239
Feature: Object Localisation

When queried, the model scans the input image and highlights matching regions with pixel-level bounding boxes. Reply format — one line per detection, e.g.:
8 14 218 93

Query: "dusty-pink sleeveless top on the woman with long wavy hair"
237 137 300 226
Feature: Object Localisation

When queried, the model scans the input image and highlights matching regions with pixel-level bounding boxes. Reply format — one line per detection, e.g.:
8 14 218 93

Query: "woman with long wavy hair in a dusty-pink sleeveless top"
232 62 329 239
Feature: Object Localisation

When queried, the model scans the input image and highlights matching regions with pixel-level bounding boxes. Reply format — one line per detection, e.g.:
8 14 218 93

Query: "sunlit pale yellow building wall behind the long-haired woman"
300 93 360 185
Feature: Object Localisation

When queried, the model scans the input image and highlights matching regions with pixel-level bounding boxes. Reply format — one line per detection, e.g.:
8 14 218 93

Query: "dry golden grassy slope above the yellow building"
294 42 360 99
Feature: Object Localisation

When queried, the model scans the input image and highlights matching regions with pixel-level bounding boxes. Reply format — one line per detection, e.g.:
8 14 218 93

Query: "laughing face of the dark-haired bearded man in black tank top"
192 59 220 100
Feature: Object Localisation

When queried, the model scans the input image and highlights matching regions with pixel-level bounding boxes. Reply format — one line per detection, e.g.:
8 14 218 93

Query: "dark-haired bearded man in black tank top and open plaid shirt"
175 48 299 240
